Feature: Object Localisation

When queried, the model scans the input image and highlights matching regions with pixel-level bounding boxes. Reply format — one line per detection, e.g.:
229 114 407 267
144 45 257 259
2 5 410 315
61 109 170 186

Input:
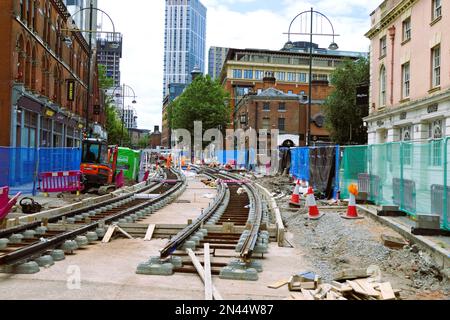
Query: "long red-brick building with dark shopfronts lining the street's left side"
0 0 105 147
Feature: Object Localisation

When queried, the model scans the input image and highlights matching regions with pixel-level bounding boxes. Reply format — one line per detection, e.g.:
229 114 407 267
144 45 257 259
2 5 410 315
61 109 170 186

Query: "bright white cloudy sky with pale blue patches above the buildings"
97 0 381 130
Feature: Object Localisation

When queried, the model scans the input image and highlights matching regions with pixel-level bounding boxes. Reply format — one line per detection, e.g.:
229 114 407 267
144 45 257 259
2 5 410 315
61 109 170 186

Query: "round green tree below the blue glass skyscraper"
168 75 231 144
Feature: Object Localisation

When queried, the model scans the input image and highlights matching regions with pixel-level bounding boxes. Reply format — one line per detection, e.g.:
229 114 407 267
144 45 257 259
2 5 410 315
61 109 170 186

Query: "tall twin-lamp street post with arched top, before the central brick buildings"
284 8 339 146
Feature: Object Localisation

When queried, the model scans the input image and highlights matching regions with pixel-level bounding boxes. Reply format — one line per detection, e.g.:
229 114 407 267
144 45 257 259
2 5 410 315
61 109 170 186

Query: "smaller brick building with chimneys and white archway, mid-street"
233 73 332 146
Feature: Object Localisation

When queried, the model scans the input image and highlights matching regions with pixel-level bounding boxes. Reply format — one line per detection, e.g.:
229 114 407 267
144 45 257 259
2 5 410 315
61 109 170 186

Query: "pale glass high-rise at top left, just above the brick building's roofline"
62 0 98 47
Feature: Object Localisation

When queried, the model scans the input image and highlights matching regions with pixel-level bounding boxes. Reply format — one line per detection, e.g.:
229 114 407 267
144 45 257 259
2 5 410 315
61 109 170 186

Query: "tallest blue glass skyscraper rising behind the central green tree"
163 0 206 98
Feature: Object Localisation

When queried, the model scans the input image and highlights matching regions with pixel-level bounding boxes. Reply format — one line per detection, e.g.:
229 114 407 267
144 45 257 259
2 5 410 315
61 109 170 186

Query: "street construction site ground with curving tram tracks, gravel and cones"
0 143 450 301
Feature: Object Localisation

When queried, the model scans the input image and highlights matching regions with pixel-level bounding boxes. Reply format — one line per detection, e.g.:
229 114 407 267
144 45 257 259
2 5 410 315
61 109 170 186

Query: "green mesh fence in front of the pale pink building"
340 138 450 230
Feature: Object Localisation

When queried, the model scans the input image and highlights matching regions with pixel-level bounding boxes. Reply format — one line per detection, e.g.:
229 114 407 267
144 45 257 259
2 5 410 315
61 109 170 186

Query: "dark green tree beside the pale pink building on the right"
324 58 370 145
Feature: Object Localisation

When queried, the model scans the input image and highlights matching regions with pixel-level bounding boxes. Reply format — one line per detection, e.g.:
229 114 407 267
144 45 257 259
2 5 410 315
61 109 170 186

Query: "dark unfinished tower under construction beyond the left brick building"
97 33 122 87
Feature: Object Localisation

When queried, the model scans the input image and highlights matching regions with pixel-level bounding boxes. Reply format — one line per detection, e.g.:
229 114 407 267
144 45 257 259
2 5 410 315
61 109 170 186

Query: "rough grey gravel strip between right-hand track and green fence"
258 177 450 299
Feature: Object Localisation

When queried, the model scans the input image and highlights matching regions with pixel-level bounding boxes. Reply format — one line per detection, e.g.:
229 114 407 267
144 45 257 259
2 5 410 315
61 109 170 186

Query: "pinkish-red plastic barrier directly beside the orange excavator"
39 171 84 193
